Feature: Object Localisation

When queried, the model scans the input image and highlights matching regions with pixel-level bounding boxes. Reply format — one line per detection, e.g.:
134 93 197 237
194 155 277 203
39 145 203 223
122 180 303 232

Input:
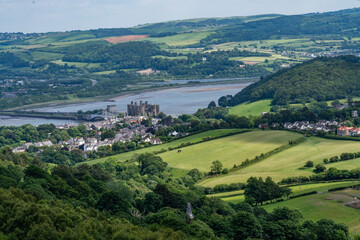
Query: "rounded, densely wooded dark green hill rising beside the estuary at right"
219 56 360 106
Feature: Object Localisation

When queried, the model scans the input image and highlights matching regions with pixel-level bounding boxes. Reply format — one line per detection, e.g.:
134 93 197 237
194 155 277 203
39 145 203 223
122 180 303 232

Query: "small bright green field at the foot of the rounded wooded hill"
229 100 271 116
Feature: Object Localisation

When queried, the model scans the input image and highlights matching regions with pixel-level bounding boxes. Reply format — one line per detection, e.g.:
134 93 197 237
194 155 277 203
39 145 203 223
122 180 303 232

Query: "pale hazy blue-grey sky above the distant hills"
0 0 360 33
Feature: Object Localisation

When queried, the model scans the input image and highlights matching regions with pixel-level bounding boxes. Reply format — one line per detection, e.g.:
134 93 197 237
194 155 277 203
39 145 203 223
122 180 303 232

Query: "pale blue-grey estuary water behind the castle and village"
0 80 251 126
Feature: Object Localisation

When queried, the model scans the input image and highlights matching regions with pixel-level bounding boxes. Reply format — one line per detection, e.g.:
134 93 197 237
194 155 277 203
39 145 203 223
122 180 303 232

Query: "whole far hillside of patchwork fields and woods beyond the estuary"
0 9 360 109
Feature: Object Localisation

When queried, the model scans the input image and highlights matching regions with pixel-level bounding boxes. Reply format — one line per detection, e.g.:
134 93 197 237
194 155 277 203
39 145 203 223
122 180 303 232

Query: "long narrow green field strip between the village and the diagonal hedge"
80 129 244 164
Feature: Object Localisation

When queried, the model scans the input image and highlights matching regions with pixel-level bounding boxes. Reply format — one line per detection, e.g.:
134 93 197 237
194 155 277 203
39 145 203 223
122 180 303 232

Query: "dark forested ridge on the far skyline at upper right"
202 9 360 43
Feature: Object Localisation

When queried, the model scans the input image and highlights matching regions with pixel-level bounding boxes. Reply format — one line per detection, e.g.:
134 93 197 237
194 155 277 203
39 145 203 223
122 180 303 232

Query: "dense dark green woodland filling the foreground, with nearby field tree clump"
0 143 349 240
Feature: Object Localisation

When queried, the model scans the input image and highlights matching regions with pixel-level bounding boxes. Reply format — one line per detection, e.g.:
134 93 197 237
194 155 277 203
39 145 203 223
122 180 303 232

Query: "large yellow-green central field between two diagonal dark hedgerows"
159 131 301 172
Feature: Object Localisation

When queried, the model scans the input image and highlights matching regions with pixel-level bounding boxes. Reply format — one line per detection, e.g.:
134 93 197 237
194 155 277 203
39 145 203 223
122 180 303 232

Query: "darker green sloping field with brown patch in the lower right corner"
264 190 360 233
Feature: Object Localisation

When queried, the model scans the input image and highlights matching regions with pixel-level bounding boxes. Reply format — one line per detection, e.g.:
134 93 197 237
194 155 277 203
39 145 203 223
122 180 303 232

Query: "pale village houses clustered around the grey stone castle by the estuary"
12 101 188 153
